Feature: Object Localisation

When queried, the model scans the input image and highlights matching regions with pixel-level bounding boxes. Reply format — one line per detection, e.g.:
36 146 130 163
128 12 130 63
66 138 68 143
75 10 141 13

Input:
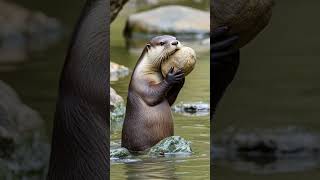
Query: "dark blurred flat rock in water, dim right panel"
218 127 320 158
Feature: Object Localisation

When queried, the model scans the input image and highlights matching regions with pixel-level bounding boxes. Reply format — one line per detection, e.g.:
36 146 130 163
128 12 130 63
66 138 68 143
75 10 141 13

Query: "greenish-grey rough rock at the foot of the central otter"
149 136 192 156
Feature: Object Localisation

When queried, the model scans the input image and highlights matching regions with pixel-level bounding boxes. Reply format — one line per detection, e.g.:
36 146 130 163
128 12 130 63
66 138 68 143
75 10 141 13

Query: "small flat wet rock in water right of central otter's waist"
172 102 210 116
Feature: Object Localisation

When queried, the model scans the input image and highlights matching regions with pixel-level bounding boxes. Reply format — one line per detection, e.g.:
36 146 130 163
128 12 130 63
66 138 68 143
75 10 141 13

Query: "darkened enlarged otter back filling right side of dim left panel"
47 0 110 180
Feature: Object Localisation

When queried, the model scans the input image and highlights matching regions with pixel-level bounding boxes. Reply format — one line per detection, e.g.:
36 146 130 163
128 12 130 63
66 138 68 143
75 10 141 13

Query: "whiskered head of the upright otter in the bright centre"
146 35 181 68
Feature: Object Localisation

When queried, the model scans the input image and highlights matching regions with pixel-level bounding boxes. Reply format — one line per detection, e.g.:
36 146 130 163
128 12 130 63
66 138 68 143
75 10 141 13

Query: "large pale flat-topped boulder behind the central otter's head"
125 5 210 39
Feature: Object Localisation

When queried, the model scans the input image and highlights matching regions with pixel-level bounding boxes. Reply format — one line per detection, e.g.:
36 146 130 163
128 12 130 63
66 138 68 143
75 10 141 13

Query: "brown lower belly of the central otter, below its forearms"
122 97 174 151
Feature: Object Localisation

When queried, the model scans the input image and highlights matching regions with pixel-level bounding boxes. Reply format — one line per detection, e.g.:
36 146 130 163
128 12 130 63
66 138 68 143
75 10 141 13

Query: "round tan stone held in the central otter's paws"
161 46 196 77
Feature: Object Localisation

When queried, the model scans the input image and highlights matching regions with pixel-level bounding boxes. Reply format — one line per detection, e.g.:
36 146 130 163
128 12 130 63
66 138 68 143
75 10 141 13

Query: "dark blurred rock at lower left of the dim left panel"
0 80 50 179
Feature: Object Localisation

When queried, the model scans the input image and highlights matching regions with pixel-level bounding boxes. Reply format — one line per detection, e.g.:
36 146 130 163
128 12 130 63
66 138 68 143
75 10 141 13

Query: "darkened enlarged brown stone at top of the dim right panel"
211 0 274 47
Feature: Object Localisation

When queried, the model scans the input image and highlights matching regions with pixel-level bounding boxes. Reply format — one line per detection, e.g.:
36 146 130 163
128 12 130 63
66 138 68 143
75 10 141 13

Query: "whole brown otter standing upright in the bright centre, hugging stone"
121 35 185 152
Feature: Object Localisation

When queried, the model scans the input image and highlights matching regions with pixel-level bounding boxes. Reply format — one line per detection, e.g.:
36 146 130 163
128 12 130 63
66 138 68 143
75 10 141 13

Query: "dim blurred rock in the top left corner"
0 0 62 64
